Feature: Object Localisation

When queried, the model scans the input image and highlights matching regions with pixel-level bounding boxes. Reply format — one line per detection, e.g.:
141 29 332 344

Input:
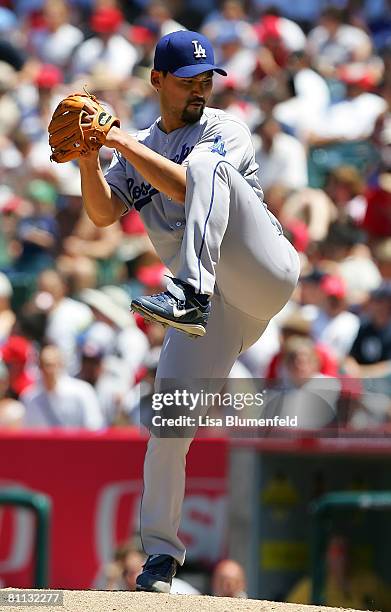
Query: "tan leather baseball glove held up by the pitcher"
48 92 120 164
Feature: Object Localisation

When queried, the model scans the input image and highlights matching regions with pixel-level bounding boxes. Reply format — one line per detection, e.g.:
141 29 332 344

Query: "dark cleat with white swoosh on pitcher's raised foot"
130 278 210 337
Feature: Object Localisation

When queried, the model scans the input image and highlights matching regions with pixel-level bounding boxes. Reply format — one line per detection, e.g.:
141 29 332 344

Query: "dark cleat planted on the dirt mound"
136 555 178 593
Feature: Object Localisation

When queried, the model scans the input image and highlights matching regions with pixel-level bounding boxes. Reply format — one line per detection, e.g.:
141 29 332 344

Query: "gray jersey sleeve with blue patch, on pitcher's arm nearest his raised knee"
183 117 258 174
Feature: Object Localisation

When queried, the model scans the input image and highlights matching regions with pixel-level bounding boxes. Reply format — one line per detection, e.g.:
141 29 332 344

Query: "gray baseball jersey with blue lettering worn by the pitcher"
105 108 282 274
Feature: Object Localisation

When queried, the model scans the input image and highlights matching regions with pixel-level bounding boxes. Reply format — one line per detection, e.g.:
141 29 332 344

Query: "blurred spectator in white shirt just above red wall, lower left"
20 345 104 429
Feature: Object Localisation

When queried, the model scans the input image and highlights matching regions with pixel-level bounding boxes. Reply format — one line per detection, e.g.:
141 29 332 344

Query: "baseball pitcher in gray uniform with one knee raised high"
55 31 299 593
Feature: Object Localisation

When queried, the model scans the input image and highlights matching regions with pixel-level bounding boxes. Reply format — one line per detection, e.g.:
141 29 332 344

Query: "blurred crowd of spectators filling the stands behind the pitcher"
0 0 391 429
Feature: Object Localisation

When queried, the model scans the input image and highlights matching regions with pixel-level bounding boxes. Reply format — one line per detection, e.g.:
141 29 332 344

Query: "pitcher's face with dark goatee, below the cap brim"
155 71 213 124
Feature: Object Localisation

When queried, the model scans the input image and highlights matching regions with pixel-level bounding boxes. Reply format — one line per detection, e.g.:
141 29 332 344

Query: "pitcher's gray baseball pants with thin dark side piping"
140 153 299 565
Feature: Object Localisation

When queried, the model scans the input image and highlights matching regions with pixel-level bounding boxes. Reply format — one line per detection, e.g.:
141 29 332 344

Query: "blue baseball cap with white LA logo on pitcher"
153 30 227 78
